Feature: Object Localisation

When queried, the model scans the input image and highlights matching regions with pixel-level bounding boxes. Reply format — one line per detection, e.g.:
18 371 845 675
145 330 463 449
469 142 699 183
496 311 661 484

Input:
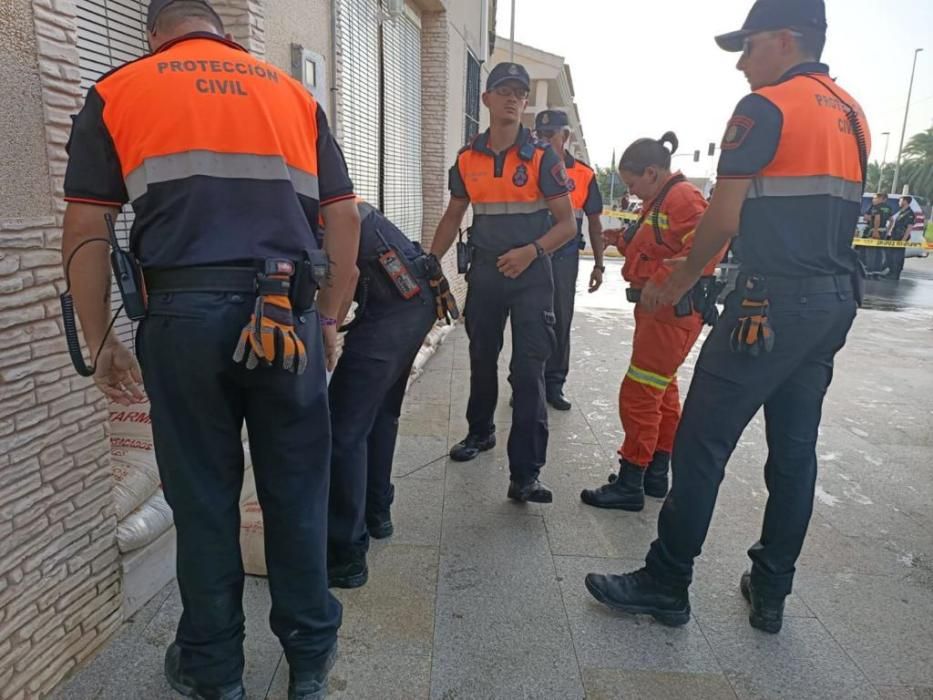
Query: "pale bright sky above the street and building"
496 0 933 176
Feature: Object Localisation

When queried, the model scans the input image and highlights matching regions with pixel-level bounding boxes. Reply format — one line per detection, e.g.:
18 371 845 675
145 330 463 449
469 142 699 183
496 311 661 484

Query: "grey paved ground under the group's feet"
57 260 933 700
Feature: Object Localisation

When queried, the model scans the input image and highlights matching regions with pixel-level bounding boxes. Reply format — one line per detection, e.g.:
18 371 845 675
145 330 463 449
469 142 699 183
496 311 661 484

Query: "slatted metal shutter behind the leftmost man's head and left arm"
76 0 149 347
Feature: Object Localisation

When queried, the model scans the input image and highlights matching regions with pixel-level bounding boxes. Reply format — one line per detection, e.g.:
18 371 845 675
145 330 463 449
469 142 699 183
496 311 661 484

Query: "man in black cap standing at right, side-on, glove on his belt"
586 0 871 633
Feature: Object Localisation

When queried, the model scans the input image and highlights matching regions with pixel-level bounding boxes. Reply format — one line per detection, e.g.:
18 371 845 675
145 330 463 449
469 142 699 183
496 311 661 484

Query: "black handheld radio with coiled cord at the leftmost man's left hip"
59 214 146 377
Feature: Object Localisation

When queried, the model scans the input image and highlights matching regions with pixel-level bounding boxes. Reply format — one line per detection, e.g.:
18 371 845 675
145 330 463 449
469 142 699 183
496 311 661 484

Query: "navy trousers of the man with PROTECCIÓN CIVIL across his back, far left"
136 292 341 686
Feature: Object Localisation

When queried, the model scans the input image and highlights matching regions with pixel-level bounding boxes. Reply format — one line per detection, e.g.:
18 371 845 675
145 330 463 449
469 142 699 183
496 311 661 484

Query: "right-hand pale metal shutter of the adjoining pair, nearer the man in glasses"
382 14 424 241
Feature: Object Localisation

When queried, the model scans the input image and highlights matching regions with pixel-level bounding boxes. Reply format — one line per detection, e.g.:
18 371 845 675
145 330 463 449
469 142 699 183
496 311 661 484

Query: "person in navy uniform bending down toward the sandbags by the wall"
327 199 447 588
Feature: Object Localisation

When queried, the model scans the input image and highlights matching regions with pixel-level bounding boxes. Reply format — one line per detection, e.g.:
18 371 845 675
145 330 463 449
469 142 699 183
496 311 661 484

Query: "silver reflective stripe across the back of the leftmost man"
126 151 320 201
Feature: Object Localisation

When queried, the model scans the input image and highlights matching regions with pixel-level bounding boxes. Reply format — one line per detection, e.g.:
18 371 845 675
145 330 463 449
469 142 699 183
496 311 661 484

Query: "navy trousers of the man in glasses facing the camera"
464 256 554 483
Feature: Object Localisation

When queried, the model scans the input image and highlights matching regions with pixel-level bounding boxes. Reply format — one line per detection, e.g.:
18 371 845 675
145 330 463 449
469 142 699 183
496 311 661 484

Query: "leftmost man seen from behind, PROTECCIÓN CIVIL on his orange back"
62 0 359 700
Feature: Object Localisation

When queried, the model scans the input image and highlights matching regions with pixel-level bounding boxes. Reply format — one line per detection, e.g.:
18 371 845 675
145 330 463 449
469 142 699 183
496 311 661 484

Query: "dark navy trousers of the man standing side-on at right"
647 277 856 596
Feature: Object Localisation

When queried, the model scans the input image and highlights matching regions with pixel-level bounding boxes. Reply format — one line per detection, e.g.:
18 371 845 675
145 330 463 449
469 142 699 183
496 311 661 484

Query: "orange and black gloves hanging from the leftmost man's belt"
233 260 308 374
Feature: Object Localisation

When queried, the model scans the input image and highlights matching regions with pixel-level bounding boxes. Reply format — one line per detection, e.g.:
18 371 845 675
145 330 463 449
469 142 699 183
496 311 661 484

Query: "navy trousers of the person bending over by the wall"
328 288 437 557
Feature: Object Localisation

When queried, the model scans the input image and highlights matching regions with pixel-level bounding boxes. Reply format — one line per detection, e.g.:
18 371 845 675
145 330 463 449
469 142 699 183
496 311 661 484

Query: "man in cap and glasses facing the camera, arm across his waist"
431 63 576 503
